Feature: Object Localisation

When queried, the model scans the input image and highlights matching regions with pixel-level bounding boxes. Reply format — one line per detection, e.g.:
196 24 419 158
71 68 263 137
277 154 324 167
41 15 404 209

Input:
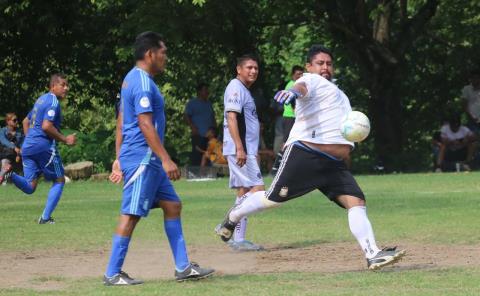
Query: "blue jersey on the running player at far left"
22 92 62 155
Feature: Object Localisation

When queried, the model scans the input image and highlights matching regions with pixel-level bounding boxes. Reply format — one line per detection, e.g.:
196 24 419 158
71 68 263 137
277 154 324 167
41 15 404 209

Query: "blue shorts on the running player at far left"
22 150 64 181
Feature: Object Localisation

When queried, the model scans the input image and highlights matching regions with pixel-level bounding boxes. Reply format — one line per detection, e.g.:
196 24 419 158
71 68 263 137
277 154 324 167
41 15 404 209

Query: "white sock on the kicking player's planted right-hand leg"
348 206 380 259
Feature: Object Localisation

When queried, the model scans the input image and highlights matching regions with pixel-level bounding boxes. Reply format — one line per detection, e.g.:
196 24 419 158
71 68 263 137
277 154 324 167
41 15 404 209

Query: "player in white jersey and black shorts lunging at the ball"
216 45 405 270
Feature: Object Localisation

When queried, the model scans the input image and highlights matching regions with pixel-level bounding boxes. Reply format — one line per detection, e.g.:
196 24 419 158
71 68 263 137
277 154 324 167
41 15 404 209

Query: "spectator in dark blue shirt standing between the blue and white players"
184 83 217 166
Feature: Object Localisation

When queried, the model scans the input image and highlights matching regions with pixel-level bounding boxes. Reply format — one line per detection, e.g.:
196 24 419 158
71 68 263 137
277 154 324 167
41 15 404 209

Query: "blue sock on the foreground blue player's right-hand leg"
164 218 190 271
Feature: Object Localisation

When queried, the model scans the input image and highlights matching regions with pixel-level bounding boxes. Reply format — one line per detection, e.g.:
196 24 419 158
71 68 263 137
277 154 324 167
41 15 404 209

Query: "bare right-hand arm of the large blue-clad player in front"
138 112 180 180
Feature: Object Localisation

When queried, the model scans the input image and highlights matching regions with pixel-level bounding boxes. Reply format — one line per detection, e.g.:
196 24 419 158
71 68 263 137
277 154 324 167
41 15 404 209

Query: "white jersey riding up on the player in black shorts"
285 73 354 147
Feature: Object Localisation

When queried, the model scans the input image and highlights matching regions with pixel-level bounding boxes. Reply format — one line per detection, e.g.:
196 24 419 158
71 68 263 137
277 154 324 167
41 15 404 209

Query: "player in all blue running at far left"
1 73 76 224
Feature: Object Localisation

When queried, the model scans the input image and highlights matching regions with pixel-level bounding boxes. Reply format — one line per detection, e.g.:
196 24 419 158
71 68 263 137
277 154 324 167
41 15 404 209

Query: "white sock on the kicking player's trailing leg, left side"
229 191 281 222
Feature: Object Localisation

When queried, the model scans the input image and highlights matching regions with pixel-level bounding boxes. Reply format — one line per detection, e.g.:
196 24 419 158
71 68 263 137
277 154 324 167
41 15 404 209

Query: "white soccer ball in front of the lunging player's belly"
340 111 370 142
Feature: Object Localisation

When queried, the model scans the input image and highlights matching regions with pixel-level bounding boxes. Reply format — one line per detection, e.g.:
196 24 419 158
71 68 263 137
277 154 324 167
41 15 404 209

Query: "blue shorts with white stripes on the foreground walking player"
121 165 180 217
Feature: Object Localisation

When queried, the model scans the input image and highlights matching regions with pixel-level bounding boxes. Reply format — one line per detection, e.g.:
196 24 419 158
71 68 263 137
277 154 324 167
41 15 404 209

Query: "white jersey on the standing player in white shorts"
223 78 260 155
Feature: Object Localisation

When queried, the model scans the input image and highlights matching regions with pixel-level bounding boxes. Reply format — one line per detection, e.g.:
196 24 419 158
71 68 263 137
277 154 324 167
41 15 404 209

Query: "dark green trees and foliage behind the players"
0 0 480 171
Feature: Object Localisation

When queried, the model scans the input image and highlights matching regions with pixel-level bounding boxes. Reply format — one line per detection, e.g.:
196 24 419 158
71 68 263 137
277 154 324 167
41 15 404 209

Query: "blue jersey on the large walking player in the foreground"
119 67 165 169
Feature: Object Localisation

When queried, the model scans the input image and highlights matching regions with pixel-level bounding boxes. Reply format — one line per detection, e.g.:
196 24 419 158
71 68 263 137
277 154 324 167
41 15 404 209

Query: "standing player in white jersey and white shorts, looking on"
223 55 265 251
